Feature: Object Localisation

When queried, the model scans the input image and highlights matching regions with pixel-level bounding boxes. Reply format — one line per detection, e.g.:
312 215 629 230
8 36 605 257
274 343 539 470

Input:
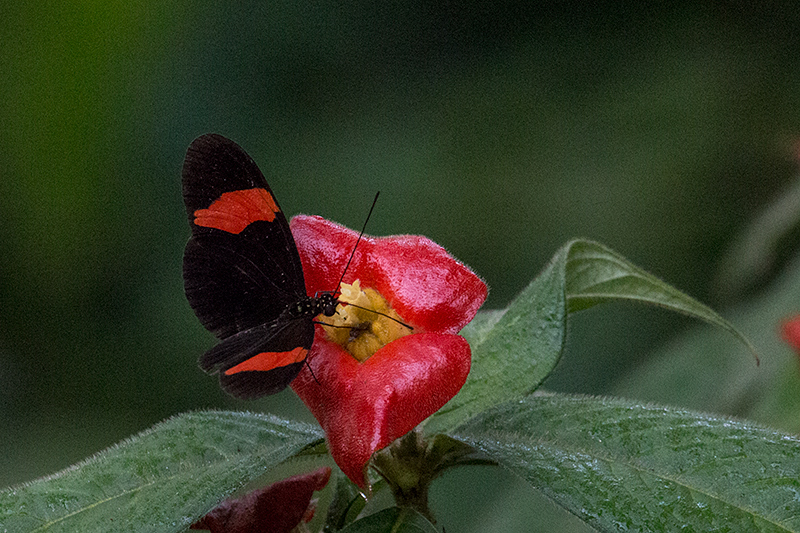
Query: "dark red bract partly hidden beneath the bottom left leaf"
189 466 331 533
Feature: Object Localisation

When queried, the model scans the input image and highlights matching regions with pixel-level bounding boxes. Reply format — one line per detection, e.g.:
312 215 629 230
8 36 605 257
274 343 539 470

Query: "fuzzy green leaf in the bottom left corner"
0 411 322 533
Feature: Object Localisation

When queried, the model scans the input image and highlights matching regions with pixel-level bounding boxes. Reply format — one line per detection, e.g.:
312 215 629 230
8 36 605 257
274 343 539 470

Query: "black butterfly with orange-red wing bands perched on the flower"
182 134 338 399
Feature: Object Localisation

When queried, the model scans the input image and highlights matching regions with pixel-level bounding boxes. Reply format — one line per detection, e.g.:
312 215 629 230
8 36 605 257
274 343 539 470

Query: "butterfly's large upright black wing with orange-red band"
183 134 305 338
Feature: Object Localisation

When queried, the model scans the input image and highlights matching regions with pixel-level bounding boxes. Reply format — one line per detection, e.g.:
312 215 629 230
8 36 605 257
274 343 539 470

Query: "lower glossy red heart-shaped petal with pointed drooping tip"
292 333 471 488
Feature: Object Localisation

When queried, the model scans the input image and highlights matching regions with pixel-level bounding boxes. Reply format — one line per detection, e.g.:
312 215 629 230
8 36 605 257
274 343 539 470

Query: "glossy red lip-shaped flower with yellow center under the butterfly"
291 216 487 488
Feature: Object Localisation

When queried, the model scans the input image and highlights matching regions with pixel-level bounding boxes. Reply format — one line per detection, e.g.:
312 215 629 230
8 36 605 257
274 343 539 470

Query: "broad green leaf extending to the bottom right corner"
455 395 800 531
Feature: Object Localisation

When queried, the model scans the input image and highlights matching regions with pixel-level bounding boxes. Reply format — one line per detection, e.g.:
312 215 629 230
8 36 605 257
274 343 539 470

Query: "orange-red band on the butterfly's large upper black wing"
194 189 280 235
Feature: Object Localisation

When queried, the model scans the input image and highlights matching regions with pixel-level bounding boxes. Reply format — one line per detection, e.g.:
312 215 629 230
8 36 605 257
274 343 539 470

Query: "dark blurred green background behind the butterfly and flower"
0 1 800 529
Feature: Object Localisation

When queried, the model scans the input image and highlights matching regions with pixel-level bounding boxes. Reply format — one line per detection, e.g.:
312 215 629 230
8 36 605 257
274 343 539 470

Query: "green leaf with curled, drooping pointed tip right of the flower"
426 240 755 433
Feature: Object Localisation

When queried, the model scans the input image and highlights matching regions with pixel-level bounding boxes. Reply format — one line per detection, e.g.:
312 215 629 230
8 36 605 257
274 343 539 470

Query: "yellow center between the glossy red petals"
320 280 412 362
